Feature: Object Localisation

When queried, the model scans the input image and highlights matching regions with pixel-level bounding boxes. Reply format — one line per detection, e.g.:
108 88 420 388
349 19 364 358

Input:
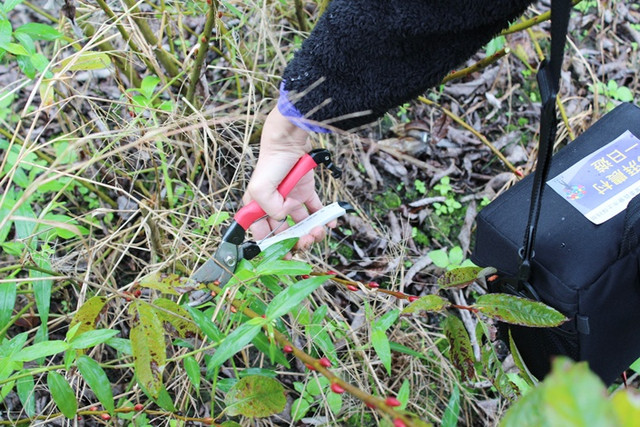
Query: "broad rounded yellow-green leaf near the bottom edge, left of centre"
224 375 287 418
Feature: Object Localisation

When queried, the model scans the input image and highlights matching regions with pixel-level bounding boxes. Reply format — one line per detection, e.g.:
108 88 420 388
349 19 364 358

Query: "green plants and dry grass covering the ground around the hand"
0 0 640 426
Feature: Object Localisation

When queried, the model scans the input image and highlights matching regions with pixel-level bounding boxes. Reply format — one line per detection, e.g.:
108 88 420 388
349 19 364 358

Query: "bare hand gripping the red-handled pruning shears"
243 107 335 249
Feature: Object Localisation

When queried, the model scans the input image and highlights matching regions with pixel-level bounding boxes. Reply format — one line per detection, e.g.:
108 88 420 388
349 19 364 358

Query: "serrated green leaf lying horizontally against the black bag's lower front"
473 294 568 327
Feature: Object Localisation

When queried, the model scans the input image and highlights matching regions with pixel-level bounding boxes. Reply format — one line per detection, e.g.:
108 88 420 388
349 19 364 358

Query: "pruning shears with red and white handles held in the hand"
189 149 353 306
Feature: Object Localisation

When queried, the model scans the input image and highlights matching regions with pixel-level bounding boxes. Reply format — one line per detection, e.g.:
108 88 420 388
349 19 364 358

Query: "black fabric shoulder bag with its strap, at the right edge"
471 0 640 383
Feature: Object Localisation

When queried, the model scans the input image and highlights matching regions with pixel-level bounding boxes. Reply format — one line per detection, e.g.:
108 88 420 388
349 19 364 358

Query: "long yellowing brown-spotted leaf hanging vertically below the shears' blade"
130 301 167 397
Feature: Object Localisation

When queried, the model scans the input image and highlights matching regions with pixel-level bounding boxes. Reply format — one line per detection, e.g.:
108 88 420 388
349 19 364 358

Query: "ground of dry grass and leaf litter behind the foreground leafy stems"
0 0 640 426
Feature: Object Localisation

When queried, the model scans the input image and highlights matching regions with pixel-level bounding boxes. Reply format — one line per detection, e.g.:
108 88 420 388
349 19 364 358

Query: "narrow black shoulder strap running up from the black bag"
518 0 571 290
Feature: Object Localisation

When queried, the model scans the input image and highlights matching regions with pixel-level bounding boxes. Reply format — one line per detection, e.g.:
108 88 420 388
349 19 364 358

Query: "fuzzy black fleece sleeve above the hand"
281 0 532 130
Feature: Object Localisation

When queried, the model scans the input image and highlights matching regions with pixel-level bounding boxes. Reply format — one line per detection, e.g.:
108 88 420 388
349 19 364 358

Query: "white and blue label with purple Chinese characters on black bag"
547 131 640 224
